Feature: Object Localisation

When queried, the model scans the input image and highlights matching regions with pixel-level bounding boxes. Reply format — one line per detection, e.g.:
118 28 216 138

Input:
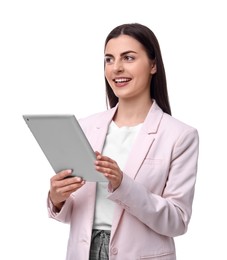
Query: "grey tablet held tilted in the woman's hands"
23 115 107 182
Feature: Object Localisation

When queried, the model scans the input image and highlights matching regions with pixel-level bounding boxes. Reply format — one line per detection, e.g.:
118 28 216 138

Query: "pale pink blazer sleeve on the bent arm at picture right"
108 128 199 237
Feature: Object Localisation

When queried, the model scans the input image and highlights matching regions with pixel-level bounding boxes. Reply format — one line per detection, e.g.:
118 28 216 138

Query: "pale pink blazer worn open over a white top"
47 101 199 260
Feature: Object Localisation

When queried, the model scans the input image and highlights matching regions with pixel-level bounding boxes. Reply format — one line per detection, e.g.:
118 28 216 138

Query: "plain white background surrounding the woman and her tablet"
0 0 227 260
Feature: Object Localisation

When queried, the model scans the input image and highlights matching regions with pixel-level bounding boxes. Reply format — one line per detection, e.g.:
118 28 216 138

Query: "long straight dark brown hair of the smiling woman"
105 23 171 115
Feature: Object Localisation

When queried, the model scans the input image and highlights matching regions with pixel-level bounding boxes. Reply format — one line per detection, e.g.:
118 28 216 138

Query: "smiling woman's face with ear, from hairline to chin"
105 35 156 100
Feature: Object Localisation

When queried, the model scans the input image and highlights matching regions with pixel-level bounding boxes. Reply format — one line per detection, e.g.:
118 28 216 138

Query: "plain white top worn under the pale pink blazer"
93 121 142 230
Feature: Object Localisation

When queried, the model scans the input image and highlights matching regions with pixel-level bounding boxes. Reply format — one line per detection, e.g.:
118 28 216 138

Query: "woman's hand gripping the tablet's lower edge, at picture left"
49 170 85 210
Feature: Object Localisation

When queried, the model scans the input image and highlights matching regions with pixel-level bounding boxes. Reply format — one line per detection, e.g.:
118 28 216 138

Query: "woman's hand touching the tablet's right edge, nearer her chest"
95 152 123 190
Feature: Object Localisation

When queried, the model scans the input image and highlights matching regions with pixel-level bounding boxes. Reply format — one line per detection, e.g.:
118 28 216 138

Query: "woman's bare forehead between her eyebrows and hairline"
105 35 144 54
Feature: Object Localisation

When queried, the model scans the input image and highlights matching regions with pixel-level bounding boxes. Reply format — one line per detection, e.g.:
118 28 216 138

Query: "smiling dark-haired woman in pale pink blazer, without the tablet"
48 23 198 260
